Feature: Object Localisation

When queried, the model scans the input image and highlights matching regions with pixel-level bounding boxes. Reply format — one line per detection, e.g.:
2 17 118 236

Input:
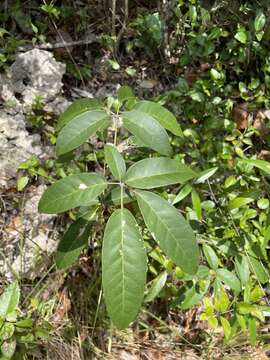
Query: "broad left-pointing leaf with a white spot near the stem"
38 173 107 214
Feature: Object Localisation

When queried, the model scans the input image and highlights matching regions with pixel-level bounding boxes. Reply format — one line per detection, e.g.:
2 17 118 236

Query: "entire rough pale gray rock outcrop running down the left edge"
0 49 67 280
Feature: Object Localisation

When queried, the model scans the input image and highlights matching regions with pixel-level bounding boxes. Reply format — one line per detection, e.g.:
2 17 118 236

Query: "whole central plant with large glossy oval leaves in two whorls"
39 86 199 329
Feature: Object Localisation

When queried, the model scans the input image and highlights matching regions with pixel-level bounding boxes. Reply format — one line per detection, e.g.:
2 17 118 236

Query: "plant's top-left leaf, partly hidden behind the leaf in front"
56 98 101 131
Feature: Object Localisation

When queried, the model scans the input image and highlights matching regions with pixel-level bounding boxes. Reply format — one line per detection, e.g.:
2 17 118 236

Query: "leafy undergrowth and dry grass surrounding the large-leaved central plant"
0 0 270 359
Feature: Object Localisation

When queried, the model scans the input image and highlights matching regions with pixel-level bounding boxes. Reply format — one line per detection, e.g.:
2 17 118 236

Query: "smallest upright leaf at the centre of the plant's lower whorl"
104 144 126 181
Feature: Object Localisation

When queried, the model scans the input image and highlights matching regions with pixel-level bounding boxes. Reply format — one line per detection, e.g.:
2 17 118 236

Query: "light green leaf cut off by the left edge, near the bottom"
0 281 20 317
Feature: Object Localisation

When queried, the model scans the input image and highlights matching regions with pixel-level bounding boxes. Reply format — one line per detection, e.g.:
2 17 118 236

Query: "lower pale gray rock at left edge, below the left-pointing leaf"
0 185 58 280
